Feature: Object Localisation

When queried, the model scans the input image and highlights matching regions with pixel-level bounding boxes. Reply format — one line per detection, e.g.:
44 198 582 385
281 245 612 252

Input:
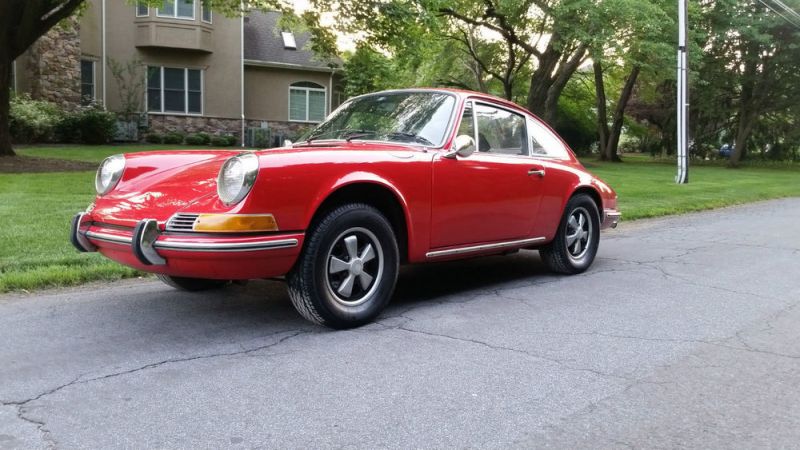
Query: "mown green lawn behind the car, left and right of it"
0 145 800 292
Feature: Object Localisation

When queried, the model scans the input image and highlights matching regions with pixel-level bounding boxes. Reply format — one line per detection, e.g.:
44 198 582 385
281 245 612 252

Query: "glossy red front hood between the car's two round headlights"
92 150 239 226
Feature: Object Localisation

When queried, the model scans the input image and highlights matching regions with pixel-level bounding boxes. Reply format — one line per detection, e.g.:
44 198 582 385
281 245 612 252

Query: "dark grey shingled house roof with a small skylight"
244 11 342 71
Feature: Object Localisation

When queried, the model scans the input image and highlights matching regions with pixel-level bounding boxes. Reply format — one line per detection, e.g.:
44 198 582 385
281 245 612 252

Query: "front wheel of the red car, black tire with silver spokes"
286 203 399 329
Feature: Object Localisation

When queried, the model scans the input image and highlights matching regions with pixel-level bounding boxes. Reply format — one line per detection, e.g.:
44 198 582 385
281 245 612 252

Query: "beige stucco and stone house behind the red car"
12 0 342 145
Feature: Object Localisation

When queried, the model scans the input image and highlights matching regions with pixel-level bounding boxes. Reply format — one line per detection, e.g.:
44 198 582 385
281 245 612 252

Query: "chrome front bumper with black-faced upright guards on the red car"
70 213 299 266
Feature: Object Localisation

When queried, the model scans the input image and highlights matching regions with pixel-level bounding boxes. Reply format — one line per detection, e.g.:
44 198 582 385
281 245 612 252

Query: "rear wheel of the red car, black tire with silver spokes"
539 194 600 275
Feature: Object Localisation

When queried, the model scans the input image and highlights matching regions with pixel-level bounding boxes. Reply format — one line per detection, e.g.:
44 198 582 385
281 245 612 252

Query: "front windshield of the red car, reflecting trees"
305 92 456 147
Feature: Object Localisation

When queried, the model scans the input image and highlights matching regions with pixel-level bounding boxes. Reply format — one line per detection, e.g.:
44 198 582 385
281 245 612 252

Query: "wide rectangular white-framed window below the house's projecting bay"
147 66 203 114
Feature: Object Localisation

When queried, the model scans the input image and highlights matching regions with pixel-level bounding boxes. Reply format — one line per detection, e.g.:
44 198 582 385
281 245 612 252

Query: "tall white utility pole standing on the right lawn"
675 0 689 184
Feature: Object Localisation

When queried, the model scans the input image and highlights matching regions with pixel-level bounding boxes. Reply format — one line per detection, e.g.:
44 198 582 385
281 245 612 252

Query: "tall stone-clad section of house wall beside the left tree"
28 19 81 109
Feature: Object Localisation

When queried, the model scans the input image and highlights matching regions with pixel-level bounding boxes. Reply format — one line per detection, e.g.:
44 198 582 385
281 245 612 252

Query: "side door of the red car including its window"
431 102 544 249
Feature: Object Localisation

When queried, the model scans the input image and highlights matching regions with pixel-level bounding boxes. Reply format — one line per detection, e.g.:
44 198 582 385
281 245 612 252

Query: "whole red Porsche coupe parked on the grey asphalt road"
71 89 620 328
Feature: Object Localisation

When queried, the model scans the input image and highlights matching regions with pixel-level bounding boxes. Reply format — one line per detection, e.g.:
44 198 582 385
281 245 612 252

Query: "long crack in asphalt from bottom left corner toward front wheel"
0 330 312 448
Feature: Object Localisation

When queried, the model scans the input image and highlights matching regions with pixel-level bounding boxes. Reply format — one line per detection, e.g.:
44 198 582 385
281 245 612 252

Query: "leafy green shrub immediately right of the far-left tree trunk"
9 95 63 144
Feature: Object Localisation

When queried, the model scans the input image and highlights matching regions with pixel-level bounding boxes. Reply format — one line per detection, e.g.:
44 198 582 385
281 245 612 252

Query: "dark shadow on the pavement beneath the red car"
103 251 551 336
